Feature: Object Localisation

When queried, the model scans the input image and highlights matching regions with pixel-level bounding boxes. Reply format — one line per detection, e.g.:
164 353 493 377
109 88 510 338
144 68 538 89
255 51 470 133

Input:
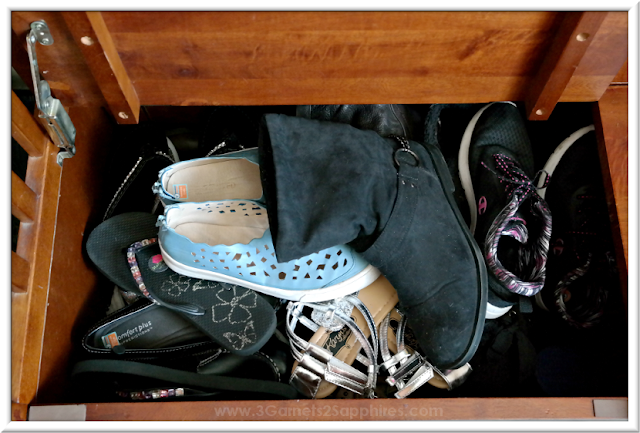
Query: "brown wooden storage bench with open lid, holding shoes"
11 11 627 420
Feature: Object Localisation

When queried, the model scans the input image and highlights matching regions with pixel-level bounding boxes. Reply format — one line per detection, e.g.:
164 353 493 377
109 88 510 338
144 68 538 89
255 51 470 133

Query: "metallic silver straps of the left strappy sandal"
286 295 378 398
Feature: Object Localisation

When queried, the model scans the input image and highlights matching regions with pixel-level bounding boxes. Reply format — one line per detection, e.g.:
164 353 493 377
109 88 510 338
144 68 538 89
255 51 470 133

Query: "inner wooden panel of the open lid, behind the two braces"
12 11 626 110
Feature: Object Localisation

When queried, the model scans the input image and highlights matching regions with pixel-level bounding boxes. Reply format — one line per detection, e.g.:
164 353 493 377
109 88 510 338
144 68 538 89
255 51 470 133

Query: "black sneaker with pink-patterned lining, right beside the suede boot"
458 103 551 318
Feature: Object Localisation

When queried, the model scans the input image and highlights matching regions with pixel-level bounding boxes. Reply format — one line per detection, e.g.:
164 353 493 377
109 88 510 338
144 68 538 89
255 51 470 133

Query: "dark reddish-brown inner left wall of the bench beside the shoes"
32 107 115 402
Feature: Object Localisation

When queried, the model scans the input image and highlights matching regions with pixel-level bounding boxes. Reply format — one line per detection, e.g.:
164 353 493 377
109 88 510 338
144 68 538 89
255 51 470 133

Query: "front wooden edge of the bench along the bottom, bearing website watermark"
75 397 627 421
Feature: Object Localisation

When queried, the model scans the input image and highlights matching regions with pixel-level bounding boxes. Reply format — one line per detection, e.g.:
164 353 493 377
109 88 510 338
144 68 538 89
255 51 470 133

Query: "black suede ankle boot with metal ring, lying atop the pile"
260 114 487 369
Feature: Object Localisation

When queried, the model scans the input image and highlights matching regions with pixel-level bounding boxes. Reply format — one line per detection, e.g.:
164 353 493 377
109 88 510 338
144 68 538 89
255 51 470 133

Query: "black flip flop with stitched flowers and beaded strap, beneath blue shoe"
87 212 276 355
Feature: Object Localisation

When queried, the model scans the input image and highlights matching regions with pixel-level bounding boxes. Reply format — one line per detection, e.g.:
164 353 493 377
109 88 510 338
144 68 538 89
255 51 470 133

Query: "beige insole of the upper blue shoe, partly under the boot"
163 159 262 202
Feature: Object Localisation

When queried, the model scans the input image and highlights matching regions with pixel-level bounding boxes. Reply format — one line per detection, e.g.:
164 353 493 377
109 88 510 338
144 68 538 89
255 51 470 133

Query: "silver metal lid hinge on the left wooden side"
27 20 76 166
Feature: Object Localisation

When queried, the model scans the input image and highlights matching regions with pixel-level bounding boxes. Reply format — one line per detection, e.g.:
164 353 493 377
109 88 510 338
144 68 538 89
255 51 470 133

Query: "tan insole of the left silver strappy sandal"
293 276 398 398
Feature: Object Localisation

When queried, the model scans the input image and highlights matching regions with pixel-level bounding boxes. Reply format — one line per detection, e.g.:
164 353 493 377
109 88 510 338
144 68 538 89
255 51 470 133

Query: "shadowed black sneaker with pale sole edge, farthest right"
536 125 618 328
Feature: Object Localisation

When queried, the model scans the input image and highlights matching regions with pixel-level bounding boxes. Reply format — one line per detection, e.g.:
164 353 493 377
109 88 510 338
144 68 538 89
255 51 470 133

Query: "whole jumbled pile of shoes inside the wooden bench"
74 103 624 400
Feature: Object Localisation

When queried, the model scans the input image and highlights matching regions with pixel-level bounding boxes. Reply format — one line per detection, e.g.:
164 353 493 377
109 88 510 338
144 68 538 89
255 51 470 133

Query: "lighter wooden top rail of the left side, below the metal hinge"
11 95 62 404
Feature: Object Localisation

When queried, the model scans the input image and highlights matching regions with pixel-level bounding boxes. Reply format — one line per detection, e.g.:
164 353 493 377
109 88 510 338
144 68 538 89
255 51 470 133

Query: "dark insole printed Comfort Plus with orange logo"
89 304 207 349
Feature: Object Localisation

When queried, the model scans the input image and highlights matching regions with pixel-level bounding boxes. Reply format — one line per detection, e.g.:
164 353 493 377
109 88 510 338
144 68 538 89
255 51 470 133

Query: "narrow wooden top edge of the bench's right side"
593 86 629 305
